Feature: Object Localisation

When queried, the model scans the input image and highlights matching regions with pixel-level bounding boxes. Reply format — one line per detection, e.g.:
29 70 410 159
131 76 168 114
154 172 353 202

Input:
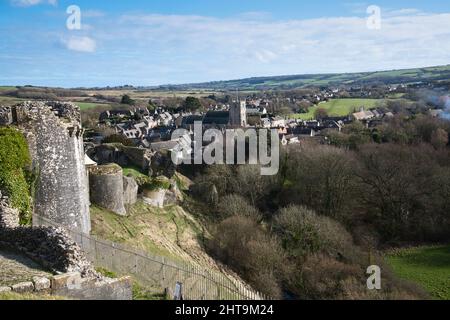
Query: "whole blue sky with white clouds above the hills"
0 0 450 87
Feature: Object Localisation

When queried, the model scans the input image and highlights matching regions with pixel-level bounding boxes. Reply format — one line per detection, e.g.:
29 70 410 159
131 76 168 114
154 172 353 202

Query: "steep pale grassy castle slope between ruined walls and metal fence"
91 201 256 298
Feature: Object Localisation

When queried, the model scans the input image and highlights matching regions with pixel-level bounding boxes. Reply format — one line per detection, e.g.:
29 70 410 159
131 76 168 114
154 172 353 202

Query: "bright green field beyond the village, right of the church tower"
293 99 383 120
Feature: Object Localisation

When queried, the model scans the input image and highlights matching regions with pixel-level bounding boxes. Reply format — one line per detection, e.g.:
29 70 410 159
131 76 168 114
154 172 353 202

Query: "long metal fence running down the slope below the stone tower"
38 217 269 300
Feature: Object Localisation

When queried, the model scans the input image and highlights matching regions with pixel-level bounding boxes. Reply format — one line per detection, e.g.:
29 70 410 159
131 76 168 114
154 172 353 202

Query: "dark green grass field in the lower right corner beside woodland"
387 246 450 300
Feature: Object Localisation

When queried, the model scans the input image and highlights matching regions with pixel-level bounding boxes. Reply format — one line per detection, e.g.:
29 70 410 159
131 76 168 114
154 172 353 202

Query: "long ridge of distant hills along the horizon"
0 65 450 95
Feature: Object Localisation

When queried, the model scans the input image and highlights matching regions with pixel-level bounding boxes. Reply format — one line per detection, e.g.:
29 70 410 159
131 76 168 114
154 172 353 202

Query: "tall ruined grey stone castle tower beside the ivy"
0 101 91 233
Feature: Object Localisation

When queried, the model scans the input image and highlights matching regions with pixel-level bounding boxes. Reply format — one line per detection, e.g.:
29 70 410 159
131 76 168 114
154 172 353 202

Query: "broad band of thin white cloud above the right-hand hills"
110 9 450 79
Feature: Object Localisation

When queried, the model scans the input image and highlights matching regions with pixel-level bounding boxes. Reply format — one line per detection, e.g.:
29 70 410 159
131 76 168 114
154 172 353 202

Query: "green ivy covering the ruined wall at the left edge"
0 128 31 224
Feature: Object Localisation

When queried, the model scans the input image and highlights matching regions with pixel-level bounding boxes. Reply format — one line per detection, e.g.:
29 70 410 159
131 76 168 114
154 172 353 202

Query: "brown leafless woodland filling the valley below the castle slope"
188 118 450 299
